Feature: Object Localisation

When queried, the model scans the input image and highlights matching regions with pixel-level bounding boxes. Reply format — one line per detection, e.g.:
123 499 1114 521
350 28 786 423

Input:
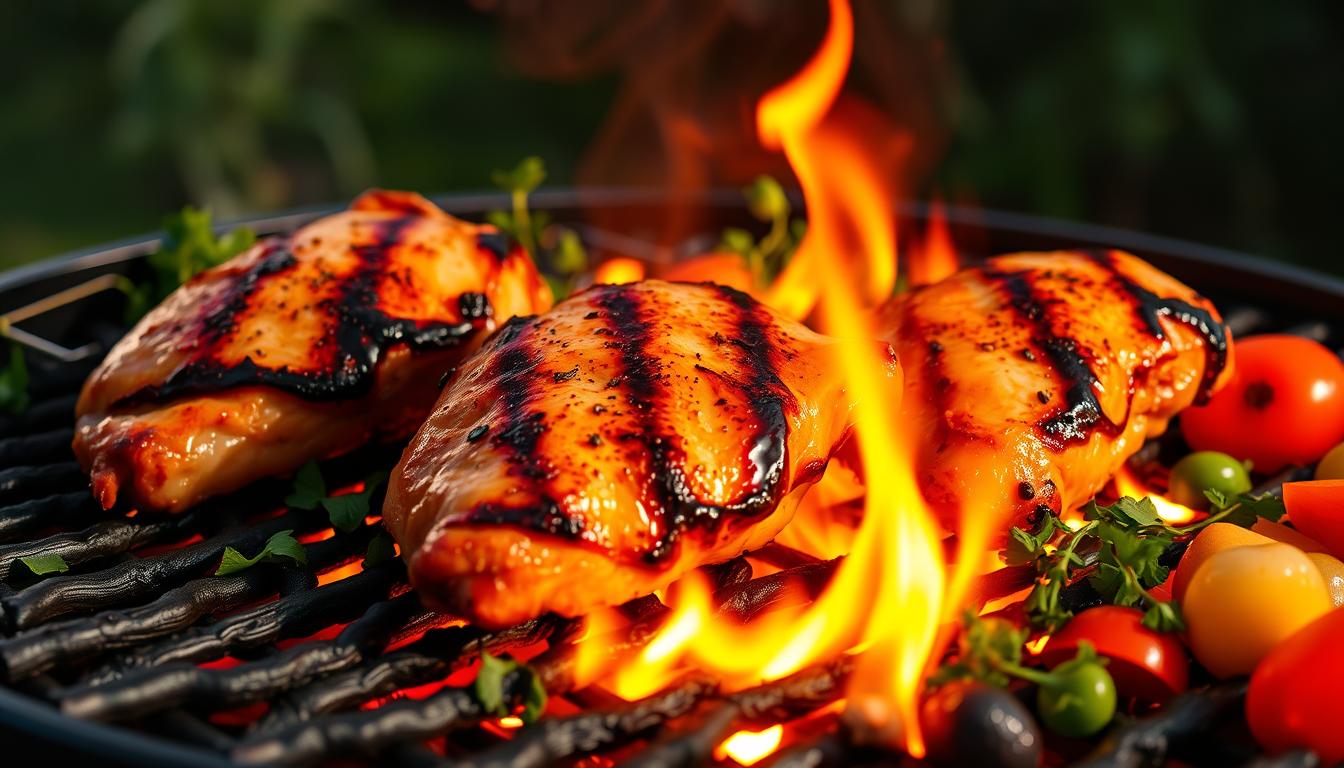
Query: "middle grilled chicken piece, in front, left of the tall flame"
383 281 881 627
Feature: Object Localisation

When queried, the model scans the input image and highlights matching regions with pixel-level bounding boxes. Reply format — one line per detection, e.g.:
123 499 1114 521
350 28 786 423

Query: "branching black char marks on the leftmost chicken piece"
116 217 491 406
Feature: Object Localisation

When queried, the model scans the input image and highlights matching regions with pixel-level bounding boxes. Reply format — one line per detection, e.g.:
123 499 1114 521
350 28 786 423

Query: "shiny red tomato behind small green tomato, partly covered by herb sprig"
1039 605 1189 702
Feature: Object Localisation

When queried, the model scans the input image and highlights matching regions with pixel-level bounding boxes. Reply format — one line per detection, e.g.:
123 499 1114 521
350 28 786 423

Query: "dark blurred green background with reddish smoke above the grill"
0 0 1344 273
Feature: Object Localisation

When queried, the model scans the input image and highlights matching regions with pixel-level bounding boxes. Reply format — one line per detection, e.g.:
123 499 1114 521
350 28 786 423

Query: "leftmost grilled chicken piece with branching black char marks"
74 191 551 511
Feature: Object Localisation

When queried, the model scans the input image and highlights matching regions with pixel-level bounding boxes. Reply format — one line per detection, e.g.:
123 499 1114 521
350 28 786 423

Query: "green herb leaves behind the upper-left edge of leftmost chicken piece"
118 206 257 321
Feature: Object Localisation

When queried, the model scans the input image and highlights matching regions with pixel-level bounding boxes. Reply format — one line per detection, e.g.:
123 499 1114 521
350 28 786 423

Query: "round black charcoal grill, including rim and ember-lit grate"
0 190 1344 767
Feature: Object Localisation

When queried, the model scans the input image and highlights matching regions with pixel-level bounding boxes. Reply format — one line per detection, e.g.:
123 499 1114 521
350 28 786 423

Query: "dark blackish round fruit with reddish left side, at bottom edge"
921 681 1043 768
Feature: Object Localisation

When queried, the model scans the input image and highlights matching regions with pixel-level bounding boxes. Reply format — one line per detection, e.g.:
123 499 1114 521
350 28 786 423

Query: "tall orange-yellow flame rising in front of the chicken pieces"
577 0 991 757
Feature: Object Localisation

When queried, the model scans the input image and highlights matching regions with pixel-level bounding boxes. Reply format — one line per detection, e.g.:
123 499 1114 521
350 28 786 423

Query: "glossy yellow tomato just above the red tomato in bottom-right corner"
1181 542 1333 678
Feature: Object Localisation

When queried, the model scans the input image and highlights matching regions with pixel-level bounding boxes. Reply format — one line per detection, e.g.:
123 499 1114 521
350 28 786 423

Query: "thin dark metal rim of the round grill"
0 188 1344 767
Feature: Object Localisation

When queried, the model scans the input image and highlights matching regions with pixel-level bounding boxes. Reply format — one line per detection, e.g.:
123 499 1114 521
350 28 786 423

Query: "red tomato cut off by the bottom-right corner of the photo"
1246 608 1344 765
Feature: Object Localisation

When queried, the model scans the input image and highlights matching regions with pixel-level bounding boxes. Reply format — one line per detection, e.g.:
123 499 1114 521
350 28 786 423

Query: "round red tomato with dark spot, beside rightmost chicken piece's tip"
1180 335 1344 472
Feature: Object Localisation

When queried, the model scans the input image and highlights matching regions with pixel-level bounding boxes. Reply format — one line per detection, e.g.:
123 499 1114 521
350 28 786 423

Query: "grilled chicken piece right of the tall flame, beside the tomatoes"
879 252 1228 535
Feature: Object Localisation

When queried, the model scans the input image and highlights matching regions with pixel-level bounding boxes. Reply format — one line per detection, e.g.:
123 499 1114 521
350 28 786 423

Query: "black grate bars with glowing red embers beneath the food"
0 200 1332 768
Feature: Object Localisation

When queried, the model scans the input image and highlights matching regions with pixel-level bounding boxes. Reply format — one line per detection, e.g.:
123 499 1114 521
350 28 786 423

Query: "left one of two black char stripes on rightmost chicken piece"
984 269 1124 451
